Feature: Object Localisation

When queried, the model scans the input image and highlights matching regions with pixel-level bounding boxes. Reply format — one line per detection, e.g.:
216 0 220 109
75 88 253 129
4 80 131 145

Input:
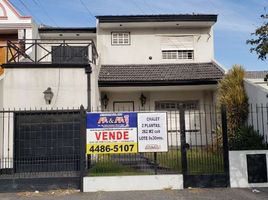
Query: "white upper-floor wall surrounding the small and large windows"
97 27 214 65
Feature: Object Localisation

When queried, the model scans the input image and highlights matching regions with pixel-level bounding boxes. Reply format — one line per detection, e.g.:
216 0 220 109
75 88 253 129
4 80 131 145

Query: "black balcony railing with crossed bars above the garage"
5 39 98 65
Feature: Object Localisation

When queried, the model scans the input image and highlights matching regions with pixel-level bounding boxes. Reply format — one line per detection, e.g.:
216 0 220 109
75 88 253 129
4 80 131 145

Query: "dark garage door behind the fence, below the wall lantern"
14 111 80 172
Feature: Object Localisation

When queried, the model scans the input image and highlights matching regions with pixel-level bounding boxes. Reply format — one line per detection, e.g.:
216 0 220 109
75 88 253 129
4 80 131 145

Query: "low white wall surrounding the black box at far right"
229 150 268 188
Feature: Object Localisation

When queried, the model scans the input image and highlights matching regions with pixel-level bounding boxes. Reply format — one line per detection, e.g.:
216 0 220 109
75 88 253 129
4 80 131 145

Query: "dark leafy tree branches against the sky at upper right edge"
247 14 268 60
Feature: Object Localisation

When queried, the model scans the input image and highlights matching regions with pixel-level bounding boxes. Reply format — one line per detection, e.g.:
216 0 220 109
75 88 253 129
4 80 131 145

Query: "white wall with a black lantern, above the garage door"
3 68 87 109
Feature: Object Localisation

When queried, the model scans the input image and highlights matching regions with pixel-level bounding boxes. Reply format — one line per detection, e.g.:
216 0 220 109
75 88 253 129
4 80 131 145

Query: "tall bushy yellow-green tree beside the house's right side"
218 65 249 139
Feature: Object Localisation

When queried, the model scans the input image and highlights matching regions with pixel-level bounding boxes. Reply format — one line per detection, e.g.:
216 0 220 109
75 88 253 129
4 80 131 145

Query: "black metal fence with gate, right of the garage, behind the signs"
87 104 225 176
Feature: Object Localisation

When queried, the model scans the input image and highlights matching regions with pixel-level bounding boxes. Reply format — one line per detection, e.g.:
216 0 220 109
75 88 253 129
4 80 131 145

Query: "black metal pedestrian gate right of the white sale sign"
179 105 229 188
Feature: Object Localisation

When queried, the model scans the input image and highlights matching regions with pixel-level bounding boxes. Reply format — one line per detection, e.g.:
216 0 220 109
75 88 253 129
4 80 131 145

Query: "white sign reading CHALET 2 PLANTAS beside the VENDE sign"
138 112 168 152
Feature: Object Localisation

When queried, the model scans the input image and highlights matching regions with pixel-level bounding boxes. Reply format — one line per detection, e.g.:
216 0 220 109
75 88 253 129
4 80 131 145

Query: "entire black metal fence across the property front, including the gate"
0 103 268 189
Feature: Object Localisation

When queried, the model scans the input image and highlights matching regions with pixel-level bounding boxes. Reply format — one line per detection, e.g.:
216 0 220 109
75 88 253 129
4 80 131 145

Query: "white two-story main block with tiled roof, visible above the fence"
97 14 224 111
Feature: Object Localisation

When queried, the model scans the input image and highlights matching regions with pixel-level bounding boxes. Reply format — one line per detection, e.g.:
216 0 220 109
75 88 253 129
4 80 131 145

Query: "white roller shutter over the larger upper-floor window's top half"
161 36 194 50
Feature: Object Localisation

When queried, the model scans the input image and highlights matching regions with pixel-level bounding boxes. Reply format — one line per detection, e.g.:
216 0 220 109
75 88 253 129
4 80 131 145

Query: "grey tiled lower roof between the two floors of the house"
99 62 224 87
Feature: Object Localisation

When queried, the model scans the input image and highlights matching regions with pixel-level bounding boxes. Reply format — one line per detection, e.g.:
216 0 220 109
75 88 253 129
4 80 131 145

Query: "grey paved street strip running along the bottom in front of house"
0 188 268 200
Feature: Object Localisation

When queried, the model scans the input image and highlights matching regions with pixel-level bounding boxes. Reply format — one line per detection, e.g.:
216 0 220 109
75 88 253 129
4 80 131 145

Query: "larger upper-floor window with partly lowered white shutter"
161 36 194 60
